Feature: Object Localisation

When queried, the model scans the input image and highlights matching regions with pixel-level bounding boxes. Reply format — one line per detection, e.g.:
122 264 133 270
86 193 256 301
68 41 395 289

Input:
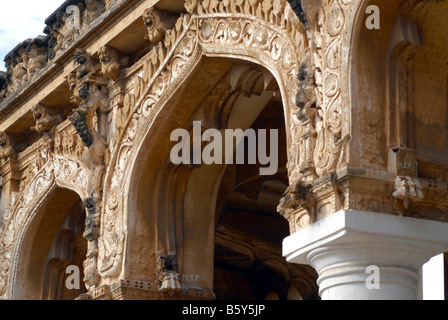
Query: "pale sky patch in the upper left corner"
0 0 64 71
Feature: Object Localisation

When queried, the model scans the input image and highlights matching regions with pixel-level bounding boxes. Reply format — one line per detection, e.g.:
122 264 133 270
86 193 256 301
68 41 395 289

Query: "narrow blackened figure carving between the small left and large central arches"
67 49 109 289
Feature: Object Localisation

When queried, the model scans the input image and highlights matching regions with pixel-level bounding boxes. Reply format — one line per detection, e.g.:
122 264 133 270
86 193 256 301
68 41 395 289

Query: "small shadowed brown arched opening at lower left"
13 188 87 300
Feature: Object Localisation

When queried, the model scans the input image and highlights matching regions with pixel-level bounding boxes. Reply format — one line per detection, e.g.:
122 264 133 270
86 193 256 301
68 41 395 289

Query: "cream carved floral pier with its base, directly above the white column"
278 0 352 232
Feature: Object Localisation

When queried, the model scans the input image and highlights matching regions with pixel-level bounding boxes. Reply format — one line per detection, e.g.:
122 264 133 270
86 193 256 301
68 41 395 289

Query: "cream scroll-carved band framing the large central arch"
98 1 306 280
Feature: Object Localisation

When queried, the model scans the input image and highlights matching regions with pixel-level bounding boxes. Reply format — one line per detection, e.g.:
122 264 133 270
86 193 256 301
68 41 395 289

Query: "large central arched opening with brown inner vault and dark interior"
124 58 317 300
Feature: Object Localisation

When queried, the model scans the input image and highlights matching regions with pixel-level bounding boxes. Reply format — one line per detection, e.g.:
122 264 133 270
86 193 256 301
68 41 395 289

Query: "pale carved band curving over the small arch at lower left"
2 155 90 299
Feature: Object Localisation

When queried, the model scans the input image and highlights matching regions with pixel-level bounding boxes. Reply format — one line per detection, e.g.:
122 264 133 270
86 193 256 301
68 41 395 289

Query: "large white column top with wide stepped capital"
283 211 448 300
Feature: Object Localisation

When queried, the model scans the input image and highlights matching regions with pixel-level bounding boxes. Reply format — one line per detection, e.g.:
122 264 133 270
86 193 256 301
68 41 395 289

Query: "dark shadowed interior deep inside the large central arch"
213 98 313 300
